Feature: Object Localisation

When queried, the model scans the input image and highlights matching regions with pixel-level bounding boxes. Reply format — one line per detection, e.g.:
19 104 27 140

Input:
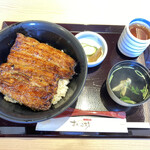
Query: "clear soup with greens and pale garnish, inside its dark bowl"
109 66 150 104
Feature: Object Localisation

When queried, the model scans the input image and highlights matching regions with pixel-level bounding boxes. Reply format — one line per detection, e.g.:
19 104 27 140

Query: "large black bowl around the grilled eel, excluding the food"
0 21 87 123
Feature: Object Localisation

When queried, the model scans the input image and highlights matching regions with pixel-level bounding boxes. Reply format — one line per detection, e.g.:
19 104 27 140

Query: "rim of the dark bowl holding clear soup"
106 60 150 107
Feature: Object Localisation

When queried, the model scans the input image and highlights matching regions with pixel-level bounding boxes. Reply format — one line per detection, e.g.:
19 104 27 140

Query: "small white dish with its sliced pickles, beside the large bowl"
75 31 108 67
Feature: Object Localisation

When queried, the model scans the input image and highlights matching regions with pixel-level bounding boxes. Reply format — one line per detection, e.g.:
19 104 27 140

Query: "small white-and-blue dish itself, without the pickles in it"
75 31 108 67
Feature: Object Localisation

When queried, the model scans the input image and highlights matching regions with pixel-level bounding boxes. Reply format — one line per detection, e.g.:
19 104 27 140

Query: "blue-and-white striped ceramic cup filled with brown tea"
118 18 150 57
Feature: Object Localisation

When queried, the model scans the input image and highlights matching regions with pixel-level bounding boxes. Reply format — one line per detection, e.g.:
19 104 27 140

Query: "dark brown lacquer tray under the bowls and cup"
0 22 150 138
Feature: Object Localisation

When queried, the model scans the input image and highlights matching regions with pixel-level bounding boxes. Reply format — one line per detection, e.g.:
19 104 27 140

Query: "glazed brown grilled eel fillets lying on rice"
0 33 76 110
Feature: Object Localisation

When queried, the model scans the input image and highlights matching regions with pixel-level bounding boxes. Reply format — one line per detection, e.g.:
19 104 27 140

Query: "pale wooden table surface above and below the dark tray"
0 0 150 150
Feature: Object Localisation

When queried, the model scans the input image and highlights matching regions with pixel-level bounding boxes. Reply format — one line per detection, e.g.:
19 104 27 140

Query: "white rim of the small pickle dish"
75 31 108 67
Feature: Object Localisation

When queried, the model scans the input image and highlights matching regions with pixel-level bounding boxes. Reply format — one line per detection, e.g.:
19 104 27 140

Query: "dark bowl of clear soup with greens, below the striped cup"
106 60 150 107
